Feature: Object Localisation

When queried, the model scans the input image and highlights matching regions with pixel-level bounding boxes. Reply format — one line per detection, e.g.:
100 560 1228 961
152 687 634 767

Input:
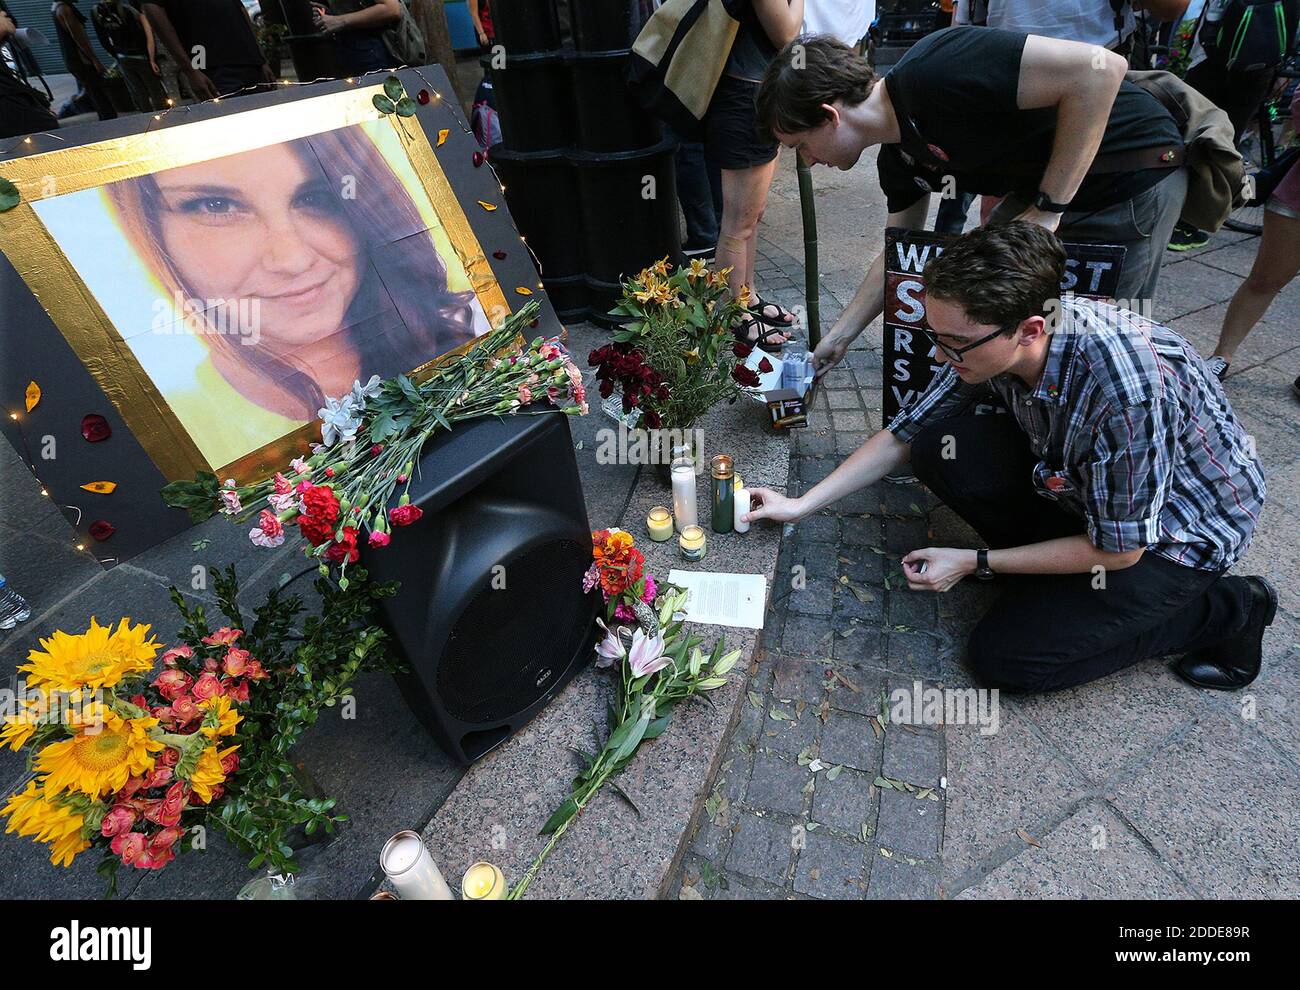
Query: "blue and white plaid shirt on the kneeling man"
889 299 1265 570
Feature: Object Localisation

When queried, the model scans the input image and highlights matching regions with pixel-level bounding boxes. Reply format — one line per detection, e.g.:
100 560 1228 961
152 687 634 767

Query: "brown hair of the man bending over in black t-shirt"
755 34 878 134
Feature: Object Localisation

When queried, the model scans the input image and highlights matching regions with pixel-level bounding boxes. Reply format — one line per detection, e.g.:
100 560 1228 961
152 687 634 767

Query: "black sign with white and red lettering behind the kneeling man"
884 227 1126 425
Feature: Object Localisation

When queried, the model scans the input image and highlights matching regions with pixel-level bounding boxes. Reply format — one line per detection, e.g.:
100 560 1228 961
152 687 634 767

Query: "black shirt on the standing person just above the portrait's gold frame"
144 0 276 100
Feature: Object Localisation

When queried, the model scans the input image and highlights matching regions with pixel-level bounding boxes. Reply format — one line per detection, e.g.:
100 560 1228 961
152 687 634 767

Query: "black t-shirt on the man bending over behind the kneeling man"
876 27 1183 213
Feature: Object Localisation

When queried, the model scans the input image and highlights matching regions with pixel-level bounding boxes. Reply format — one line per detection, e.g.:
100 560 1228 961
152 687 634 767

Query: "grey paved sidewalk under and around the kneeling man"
679 146 1300 899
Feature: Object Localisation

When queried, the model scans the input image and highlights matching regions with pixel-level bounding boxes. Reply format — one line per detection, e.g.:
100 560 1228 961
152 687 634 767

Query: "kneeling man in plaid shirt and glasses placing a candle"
749 222 1277 691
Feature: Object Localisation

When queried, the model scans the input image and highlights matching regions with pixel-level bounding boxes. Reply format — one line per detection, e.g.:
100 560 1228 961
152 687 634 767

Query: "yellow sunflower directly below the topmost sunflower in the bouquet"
36 704 164 798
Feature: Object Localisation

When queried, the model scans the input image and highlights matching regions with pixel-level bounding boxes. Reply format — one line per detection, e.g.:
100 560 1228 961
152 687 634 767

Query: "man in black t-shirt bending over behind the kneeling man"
758 27 1187 373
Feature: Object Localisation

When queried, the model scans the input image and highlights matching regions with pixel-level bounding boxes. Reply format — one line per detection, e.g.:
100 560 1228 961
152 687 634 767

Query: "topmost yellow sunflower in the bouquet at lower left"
18 617 159 694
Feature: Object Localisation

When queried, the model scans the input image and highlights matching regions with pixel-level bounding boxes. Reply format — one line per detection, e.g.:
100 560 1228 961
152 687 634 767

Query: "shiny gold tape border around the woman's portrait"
0 86 511 481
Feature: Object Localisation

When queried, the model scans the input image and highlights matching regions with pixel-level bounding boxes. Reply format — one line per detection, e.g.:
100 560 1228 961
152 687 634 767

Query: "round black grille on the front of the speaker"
438 539 592 722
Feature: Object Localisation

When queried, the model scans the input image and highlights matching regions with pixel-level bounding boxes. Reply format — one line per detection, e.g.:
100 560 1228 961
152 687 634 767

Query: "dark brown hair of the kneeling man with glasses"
926 221 1065 334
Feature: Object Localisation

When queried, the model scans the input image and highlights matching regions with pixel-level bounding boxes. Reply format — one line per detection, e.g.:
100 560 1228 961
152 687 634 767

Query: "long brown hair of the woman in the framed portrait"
105 126 475 412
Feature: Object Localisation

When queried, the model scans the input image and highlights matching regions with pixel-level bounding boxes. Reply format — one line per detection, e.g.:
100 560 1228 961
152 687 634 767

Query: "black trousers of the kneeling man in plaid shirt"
911 416 1249 691
